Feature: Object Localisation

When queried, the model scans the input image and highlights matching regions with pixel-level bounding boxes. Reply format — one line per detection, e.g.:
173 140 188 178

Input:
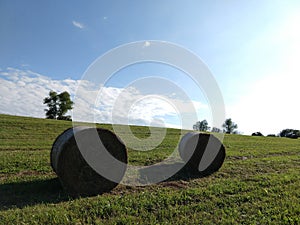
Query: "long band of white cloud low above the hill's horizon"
0 68 205 129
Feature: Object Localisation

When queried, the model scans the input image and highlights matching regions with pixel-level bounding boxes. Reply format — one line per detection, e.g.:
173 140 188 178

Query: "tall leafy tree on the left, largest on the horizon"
44 91 74 120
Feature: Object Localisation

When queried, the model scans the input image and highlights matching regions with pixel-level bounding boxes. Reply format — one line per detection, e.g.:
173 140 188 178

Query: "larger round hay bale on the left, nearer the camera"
51 127 127 196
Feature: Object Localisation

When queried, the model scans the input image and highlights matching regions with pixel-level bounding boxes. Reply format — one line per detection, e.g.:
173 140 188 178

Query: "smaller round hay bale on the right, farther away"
179 132 226 175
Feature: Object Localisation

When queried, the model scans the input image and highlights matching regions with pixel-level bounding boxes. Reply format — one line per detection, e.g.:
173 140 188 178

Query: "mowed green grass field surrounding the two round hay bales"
0 115 300 224
